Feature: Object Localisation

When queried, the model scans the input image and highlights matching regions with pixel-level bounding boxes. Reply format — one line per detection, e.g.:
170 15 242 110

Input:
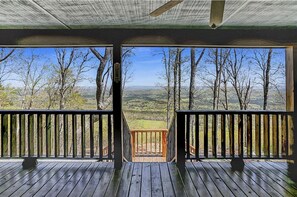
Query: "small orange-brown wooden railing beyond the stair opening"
130 129 167 157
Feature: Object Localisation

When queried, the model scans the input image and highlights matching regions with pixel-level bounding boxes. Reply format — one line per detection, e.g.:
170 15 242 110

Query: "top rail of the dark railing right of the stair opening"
176 110 293 114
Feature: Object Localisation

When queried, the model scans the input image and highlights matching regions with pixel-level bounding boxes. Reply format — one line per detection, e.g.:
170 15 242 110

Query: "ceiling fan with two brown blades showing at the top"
150 0 225 29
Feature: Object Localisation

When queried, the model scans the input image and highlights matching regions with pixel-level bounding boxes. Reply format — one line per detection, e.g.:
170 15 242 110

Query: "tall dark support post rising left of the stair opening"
112 43 123 169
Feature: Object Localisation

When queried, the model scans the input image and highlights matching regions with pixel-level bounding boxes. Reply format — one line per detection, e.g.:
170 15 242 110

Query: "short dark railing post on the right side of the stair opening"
176 112 186 174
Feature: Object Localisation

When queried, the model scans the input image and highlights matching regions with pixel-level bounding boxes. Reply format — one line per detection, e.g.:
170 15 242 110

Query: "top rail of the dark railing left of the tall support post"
0 109 113 114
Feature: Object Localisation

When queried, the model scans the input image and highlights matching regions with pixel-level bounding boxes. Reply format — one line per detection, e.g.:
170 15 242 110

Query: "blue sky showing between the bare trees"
1 47 285 86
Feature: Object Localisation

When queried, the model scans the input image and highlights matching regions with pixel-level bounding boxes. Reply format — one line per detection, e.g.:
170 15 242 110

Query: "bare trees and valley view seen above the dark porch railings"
0 47 286 128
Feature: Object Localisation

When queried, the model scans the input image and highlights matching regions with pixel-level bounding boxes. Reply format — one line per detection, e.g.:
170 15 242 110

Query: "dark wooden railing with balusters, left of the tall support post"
0 110 113 160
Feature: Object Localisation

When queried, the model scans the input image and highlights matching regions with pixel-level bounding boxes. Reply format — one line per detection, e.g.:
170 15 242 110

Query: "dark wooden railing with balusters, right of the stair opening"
176 111 293 167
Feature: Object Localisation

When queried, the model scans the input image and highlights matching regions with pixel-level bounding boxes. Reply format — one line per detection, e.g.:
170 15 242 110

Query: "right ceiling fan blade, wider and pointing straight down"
209 0 225 28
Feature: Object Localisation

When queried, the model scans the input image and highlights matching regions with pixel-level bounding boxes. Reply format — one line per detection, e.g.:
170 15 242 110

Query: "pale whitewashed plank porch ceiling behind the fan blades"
0 0 297 29
